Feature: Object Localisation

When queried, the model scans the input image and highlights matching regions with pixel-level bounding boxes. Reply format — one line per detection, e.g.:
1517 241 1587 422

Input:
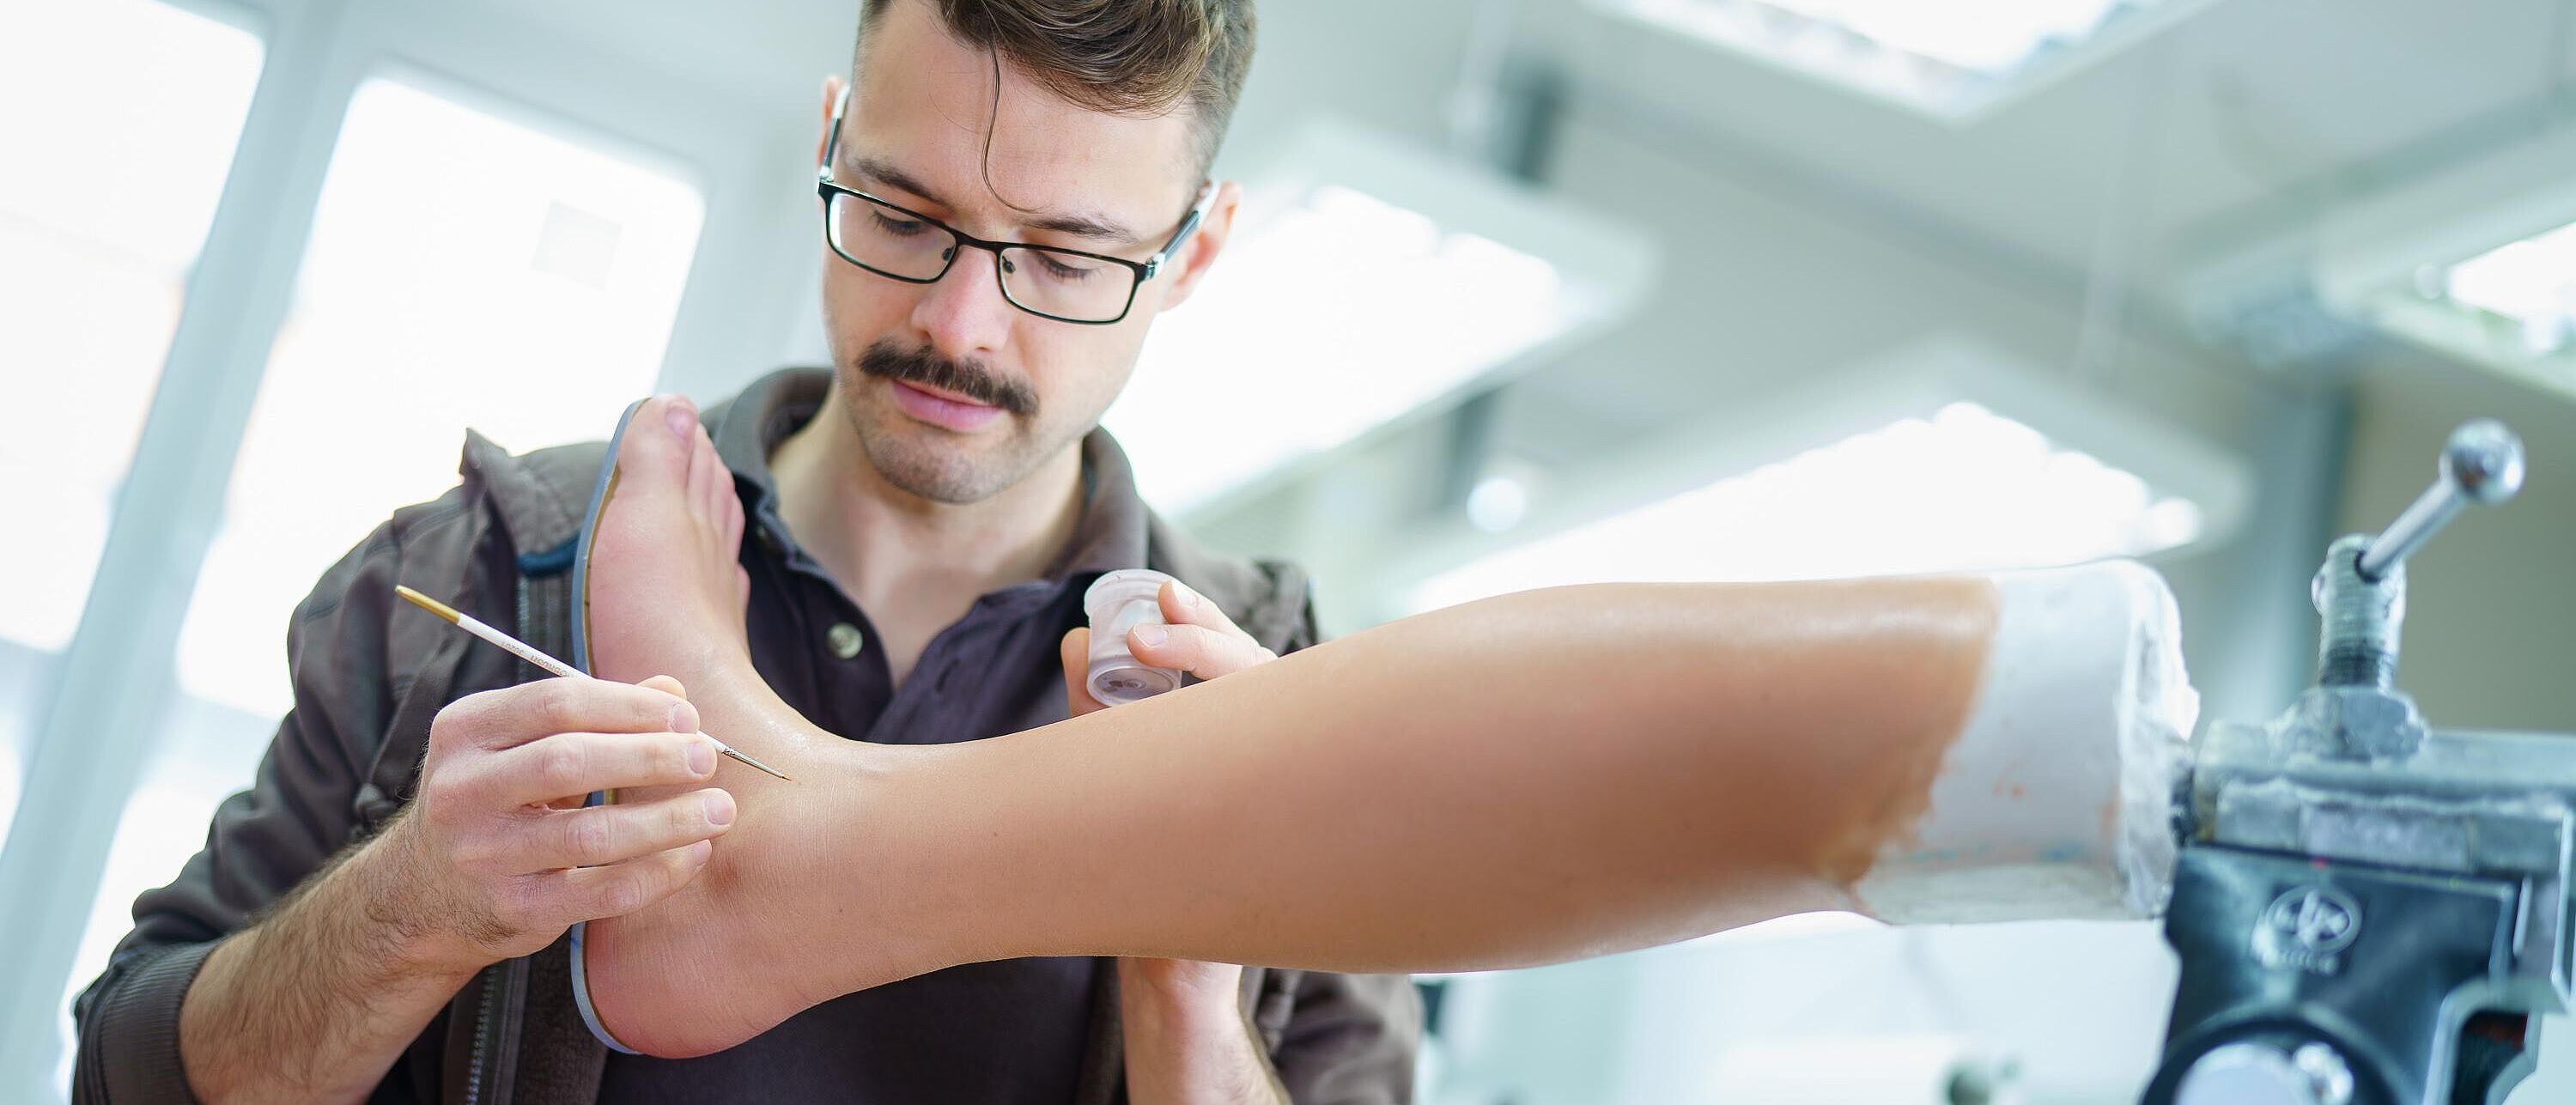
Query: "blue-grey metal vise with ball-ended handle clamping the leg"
2146 420 2576 1105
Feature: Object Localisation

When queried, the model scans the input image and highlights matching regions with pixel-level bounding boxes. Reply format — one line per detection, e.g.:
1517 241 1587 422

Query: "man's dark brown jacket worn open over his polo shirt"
72 373 1422 1105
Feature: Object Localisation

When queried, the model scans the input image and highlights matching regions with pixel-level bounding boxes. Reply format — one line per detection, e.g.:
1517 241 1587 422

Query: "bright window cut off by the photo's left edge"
0 0 263 855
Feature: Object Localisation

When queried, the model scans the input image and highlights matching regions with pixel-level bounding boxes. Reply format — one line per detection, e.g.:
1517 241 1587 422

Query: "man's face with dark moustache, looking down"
822 0 1234 502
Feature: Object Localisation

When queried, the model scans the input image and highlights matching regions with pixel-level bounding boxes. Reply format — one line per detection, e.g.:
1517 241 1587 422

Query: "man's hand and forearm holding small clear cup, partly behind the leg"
1061 582 1288 1105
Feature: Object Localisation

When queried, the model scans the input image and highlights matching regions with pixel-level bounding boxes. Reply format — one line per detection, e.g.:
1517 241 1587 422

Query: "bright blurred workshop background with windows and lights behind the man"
0 0 2576 1105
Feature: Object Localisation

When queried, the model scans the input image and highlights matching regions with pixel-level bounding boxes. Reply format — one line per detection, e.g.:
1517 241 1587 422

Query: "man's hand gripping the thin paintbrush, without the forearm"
376 677 734 968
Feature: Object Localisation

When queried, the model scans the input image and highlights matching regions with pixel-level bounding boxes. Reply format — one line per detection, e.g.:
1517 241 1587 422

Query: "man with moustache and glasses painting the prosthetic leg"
75 0 1419 1102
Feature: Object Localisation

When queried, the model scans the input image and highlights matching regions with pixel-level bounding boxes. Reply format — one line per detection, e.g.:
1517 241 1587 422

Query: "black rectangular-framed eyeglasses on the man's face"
814 88 1216 327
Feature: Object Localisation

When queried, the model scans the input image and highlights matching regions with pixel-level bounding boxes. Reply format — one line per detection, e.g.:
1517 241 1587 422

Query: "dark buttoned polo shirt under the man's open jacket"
600 373 1146 1105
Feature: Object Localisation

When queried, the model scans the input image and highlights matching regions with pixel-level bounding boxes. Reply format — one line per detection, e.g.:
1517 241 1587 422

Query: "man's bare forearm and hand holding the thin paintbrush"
178 680 734 1105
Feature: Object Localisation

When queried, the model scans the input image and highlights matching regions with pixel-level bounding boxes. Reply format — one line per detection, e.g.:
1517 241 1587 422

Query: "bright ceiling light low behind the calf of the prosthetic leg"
1399 343 2246 613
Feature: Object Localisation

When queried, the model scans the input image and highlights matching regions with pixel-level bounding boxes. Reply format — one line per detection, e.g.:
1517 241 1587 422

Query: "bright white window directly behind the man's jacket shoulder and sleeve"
72 77 706 1066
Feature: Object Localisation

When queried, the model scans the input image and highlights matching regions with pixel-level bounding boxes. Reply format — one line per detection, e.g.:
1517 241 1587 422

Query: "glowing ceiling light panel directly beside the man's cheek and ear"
1103 124 1649 513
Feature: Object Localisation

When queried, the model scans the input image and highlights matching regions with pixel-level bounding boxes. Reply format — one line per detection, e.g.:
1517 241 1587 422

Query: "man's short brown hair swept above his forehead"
853 0 1252 175
